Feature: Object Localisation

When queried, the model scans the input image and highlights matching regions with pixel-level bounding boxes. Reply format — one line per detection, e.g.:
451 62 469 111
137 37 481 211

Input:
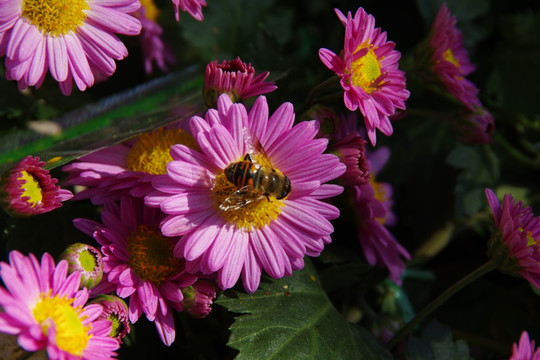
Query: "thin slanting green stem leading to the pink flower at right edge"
386 260 497 350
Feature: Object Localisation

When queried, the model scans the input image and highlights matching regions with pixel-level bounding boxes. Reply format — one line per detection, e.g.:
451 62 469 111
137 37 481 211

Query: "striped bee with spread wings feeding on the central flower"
219 129 291 211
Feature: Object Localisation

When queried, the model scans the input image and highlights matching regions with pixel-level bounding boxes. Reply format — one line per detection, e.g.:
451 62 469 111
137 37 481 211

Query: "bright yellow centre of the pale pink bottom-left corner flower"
32 293 92 356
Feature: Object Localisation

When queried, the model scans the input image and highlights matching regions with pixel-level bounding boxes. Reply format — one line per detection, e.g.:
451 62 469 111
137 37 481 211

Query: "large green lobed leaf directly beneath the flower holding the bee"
217 259 392 360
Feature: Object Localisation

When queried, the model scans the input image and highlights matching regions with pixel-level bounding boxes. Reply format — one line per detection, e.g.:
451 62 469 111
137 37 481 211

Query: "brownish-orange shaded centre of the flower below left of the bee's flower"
127 224 184 286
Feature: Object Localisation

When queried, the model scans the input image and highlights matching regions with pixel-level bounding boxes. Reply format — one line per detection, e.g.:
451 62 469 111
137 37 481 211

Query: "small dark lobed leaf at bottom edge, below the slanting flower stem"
406 322 472 360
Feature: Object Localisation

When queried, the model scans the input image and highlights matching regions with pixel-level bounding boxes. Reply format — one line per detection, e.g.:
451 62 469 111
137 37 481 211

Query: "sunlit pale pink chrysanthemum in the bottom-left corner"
0 251 118 360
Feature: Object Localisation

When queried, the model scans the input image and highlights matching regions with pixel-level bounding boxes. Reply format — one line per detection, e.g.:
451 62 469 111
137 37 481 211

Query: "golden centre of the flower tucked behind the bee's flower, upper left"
127 128 199 175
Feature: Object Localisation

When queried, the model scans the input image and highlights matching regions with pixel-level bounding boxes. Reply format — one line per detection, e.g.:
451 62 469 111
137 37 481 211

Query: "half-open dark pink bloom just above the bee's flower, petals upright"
203 57 277 108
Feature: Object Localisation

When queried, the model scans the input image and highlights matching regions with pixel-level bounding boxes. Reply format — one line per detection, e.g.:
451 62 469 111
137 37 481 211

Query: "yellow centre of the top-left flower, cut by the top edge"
21 0 90 36
